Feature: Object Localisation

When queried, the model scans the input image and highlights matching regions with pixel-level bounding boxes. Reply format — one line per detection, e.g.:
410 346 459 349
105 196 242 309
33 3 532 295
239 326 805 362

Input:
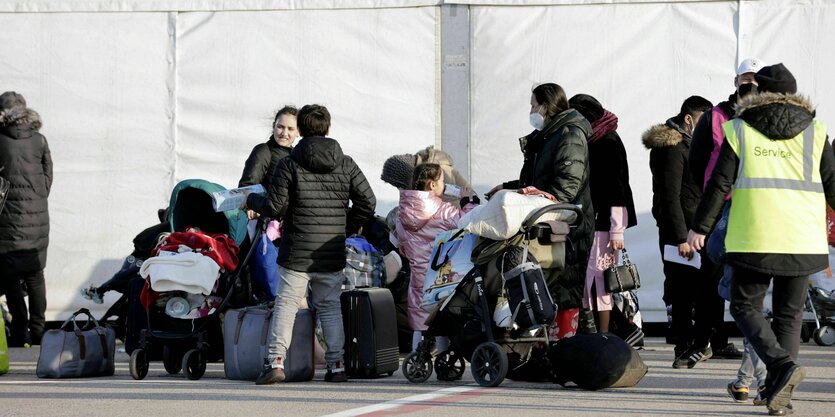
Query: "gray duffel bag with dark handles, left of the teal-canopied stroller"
36 308 116 378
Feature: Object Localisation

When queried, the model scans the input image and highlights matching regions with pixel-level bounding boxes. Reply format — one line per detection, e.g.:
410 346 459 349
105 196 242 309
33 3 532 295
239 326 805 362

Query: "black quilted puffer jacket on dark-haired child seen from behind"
247 137 376 272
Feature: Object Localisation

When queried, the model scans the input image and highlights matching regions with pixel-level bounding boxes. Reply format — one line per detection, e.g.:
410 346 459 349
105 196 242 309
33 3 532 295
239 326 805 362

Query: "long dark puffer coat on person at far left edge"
0 107 52 272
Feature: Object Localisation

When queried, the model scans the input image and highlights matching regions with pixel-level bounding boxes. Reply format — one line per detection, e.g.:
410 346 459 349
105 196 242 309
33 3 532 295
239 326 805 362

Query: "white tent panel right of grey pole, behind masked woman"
471 3 736 321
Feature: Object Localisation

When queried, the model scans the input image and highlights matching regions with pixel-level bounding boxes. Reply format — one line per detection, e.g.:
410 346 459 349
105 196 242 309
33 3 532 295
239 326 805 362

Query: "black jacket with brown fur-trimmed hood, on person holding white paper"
642 119 702 246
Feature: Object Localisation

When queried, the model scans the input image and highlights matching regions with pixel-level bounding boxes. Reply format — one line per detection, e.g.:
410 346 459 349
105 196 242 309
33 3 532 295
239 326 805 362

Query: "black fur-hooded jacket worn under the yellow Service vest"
693 93 835 276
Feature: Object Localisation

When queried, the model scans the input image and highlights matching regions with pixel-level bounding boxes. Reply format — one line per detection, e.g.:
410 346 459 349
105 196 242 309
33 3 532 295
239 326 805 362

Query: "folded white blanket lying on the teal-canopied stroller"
139 252 220 295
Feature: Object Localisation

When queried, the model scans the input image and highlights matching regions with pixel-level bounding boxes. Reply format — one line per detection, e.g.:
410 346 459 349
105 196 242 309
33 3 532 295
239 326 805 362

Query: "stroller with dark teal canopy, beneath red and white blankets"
130 180 253 380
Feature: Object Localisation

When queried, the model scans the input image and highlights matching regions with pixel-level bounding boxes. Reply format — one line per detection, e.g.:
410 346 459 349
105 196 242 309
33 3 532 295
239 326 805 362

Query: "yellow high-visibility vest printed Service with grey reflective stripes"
722 119 829 254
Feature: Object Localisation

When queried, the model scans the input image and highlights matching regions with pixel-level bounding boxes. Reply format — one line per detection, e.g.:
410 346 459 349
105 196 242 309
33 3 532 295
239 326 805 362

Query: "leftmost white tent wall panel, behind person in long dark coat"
0 13 174 319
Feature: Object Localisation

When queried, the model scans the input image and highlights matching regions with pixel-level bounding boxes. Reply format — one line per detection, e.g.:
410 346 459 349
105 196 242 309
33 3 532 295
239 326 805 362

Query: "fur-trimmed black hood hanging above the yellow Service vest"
734 92 815 139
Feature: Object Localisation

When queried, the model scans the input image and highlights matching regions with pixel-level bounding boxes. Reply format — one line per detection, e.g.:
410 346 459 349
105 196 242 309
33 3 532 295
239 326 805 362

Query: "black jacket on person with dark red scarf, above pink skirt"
589 132 638 232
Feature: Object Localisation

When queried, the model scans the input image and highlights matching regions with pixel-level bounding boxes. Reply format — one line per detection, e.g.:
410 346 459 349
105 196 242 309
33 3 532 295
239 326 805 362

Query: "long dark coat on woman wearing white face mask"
503 109 594 309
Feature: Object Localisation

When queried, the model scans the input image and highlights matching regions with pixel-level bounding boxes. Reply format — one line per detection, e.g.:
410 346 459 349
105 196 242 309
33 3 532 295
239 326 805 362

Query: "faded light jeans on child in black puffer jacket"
267 266 345 368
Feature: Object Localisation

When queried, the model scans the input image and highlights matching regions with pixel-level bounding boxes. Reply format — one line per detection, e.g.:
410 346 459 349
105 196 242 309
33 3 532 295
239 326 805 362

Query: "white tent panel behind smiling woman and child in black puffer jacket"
176 8 436 205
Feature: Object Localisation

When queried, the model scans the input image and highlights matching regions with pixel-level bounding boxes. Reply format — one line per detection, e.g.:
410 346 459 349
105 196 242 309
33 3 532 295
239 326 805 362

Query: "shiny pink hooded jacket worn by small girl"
397 190 464 330
